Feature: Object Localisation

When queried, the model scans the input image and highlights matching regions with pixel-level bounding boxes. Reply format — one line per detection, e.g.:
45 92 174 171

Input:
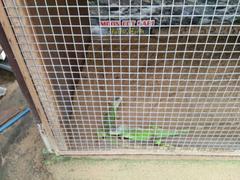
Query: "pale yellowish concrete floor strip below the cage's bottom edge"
48 159 240 180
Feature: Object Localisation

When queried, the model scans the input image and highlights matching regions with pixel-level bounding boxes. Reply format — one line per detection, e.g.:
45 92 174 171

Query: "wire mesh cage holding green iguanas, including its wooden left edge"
3 0 240 154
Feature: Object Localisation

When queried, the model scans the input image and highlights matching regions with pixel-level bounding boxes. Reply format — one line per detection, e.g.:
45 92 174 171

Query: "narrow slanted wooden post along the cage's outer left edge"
0 1 58 153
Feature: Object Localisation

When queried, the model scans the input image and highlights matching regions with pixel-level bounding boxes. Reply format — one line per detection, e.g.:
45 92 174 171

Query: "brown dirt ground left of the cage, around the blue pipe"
0 70 51 180
